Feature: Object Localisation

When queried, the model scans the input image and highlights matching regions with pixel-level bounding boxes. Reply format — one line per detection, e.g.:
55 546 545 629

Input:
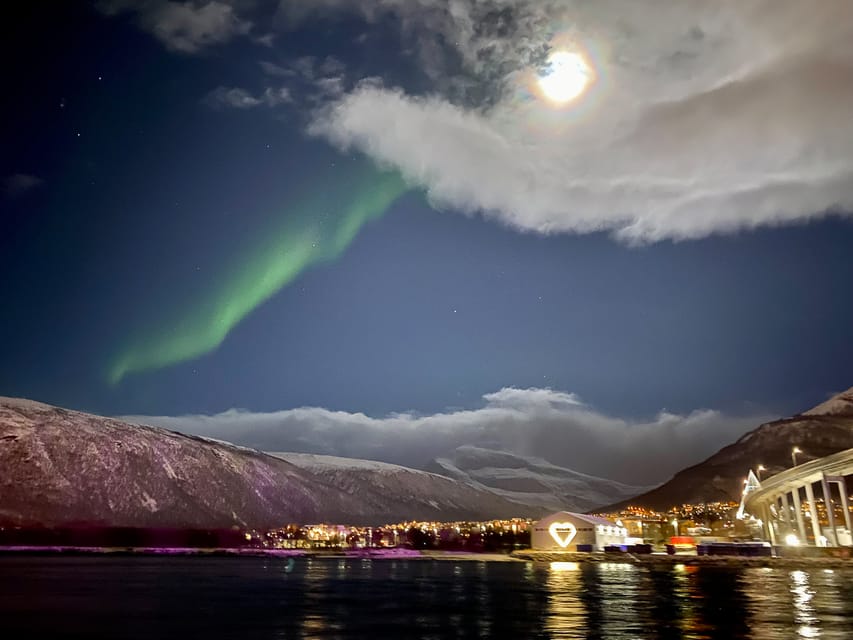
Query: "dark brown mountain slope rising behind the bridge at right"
608 388 853 510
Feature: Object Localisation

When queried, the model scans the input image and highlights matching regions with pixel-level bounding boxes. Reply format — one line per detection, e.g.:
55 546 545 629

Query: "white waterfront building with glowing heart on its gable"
530 511 628 551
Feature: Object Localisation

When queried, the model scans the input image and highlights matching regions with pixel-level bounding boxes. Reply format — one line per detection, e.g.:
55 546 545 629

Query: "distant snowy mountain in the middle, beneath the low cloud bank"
427 446 649 512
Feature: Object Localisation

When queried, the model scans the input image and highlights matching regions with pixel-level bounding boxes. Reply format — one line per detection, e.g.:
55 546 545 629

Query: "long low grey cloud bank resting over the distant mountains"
127 387 770 484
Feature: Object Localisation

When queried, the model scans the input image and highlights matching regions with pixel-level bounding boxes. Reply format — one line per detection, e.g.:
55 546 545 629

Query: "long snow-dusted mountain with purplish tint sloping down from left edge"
0 398 529 529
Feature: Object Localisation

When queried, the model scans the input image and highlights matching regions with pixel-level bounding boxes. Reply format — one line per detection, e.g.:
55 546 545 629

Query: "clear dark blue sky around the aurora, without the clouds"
0 3 853 424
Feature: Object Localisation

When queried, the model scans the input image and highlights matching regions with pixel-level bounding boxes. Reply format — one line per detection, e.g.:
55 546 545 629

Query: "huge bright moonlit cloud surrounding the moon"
298 0 853 243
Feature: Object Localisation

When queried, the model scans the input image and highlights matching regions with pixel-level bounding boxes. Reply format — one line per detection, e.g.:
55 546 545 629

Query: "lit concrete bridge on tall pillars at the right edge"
743 449 853 547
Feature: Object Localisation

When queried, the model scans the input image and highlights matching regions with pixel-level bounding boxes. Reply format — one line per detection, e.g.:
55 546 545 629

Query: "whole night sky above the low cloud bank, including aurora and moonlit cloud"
0 0 853 479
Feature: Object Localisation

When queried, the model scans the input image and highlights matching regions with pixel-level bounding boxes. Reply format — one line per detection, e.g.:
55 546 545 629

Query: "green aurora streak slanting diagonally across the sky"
107 170 407 385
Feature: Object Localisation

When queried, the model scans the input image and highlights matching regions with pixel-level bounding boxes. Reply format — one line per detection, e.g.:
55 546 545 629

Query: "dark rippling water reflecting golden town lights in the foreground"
0 557 853 640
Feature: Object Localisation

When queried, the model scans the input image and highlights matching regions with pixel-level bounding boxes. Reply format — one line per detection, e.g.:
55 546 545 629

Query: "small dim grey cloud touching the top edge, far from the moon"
99 0 252 53
